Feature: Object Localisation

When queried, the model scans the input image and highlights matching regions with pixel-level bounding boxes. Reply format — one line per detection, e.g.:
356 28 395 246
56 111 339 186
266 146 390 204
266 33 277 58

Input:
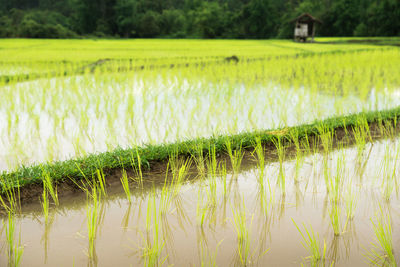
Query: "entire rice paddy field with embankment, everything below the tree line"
0 38 400 266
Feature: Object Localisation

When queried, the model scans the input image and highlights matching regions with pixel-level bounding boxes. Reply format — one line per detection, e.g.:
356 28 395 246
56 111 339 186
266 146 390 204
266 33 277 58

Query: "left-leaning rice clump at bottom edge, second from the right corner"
292 219 326 266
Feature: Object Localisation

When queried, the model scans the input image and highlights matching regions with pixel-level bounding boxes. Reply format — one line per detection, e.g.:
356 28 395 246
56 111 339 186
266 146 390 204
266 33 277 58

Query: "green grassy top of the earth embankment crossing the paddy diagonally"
1 107 400 195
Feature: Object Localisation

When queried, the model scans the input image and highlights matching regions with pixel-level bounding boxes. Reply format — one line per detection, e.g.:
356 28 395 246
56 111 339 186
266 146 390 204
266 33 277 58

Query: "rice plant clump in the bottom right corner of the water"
364 206 397 266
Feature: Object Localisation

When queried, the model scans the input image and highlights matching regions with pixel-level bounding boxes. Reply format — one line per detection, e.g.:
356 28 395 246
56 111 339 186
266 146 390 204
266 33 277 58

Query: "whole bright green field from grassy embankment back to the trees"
0 39 400 173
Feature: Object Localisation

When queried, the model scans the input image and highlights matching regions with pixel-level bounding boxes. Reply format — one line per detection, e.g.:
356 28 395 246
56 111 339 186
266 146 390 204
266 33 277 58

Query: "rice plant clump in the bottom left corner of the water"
3 212 24 267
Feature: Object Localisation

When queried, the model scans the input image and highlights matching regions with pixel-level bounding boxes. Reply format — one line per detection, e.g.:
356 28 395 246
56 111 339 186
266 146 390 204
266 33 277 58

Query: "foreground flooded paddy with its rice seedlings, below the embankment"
2 110 400 266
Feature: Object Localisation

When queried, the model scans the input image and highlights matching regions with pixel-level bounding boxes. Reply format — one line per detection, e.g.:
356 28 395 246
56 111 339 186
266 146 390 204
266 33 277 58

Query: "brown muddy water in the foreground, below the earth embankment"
0 139 400 266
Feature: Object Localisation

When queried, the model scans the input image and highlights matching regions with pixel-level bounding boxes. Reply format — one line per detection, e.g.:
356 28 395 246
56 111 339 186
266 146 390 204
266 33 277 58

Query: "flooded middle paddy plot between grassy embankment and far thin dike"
0 41 400 174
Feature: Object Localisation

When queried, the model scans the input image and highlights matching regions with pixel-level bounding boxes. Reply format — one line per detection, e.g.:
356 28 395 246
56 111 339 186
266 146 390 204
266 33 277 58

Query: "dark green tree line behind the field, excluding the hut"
0 0 400 39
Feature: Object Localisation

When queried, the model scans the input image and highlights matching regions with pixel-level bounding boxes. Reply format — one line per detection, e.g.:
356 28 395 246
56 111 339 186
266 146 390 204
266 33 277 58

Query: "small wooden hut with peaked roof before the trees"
291 13 322 42
